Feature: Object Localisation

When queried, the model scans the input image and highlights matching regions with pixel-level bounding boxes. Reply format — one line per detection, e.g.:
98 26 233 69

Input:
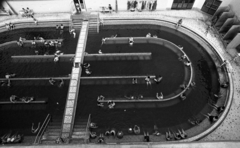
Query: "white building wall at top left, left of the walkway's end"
8 0 72 13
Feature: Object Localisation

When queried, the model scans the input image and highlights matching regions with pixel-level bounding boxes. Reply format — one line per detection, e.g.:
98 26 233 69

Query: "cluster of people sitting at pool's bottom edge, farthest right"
165 129 187 141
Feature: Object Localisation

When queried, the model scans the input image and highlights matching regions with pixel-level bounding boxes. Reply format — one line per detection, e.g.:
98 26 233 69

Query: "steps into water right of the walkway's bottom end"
71 117 88 143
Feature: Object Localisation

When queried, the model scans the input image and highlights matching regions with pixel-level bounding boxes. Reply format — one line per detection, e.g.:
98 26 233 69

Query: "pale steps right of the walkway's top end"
88 13 99 35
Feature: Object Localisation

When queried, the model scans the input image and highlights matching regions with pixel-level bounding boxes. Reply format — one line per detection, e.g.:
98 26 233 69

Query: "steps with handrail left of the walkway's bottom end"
41 116 63 144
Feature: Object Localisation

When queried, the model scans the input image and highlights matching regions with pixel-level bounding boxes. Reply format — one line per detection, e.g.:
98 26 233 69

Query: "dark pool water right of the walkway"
77 25 219 133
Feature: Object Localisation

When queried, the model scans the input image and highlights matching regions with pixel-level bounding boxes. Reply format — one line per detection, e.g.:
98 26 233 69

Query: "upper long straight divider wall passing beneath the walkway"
11 52 152 63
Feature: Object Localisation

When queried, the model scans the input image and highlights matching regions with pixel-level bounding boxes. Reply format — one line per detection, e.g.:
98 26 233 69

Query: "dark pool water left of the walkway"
0 28 79 136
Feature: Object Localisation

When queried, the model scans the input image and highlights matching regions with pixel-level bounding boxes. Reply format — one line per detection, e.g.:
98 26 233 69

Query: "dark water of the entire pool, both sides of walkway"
0 20 228 142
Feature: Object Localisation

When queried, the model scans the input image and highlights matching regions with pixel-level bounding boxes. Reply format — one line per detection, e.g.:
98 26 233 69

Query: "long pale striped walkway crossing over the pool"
61 22 88 138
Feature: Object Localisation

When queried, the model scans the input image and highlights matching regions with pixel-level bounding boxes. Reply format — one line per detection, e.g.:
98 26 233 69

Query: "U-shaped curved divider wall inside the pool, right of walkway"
96 37 193 108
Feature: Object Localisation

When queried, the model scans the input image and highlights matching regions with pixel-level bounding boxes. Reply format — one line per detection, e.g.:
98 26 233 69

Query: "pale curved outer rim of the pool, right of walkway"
101 18 233 142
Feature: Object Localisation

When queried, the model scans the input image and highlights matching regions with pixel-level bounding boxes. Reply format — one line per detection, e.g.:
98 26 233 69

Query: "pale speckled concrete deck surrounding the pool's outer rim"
0 10 240 147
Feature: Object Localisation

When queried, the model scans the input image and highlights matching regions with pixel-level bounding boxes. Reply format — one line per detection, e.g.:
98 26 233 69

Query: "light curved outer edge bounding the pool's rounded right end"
101 18 234 143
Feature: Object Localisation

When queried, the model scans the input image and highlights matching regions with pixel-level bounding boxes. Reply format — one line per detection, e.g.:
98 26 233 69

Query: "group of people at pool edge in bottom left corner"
0 131 23 144
